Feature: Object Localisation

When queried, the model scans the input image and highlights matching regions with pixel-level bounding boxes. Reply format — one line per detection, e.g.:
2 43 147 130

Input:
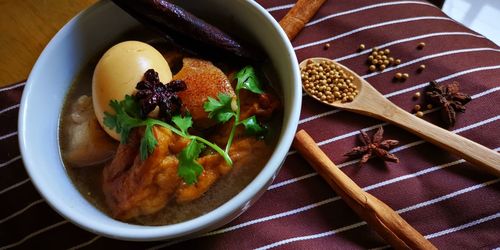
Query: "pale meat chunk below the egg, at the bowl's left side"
62 95 117 167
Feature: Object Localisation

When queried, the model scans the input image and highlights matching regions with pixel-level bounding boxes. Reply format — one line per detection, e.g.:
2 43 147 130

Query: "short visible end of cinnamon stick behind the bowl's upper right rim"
280 0 326 41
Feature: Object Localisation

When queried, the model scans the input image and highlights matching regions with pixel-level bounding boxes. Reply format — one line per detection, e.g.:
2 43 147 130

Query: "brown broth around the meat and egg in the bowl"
59 38 283 225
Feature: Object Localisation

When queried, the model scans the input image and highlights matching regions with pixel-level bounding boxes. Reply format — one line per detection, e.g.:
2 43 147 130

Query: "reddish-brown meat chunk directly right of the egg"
173 57 235 128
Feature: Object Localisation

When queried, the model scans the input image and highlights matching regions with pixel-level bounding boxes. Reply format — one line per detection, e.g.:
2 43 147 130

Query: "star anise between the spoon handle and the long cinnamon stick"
345 127 399 164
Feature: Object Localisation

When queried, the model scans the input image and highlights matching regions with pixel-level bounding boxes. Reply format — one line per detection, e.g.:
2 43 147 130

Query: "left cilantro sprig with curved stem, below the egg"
104 95 233 184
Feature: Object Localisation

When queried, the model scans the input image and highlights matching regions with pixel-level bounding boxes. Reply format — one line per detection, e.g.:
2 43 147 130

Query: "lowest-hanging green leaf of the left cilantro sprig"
177 140 205 185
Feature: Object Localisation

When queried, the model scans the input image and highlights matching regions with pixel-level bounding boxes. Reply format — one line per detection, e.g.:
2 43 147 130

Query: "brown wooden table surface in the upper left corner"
0 0 97 87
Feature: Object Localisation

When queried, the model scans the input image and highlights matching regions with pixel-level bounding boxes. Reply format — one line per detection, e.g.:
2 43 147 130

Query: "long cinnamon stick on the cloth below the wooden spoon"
293 130 437 249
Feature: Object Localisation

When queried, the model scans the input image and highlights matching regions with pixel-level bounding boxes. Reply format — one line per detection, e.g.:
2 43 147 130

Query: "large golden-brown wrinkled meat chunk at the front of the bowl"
103 127 189 220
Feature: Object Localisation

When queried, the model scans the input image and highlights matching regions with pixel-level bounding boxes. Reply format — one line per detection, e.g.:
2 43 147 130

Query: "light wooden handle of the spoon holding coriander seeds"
369 95 500 176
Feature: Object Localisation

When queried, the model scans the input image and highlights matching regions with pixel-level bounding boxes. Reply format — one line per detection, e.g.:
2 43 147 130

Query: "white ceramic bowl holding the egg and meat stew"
19 0 302 240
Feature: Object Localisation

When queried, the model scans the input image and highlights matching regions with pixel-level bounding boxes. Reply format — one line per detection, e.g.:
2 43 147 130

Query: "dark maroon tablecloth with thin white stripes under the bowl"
0 0 500 249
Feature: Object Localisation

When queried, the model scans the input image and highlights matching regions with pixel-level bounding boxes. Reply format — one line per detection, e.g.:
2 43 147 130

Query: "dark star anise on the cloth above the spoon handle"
425 81 471 127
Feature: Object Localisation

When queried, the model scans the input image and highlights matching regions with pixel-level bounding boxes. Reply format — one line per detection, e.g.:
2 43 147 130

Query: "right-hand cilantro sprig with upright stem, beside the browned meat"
203 66 266 154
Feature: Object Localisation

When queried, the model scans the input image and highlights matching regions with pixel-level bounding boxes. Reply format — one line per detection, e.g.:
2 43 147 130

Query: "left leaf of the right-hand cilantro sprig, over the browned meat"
203 93 236 123
